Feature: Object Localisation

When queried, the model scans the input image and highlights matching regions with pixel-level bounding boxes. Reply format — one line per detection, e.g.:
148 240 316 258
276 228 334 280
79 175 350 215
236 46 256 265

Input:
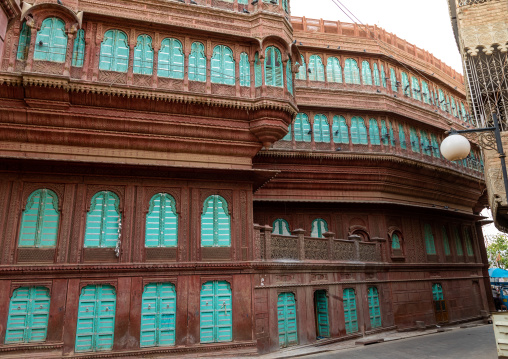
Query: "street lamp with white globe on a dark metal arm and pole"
441 112 508 196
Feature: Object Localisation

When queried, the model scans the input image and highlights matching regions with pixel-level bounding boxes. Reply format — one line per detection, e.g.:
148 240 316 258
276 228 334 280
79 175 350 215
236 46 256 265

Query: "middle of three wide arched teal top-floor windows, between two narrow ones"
157 38 185 82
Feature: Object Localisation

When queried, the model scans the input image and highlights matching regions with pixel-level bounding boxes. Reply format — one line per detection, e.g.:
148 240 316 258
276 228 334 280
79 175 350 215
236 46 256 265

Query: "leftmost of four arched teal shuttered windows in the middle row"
18 189 60 248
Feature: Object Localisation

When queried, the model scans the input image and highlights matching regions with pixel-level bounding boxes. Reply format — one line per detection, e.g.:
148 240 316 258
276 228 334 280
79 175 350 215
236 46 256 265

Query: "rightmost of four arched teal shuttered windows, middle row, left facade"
201 195 231 247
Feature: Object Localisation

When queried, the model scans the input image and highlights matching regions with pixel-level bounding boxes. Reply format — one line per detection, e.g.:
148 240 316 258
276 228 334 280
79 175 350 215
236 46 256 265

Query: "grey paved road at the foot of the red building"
305 325 497 359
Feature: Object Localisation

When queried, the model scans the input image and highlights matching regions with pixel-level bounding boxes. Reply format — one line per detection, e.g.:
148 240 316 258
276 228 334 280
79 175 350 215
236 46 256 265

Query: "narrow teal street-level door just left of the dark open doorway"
277 293 298 348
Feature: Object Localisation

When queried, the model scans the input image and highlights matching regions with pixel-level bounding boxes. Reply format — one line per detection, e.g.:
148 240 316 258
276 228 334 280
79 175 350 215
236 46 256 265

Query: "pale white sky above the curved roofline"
291 0 462 73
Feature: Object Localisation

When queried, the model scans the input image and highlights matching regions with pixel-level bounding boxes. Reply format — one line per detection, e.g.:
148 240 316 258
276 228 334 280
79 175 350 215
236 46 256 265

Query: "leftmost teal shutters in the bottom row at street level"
4 287 50 344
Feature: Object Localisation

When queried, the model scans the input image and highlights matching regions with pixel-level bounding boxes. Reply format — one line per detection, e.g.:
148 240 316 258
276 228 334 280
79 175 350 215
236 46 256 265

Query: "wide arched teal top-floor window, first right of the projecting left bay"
99 30 129 72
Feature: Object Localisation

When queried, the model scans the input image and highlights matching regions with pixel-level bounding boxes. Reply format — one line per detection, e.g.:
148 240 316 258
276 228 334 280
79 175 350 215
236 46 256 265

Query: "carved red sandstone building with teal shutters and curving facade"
0 0 490 357
